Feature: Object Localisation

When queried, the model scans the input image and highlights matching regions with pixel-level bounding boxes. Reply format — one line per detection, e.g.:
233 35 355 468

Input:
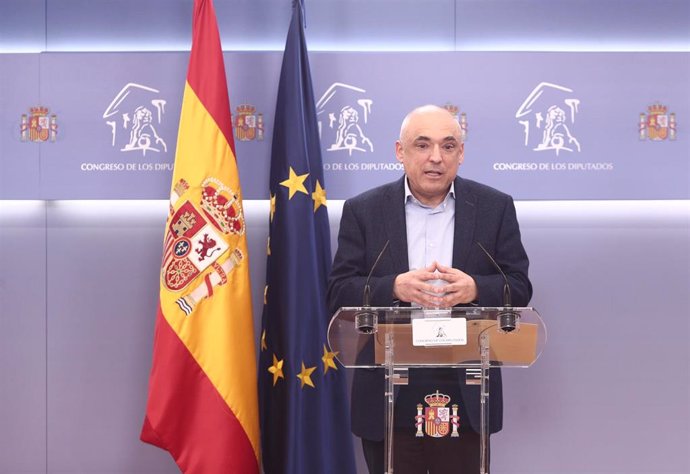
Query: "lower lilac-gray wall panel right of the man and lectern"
492 201 690 474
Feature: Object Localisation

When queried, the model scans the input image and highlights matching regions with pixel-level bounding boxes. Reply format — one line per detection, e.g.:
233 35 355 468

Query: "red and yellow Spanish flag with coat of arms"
141 0 260 474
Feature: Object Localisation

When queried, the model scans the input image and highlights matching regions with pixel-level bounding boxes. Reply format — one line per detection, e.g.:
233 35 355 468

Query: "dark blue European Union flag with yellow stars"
259 1 356 474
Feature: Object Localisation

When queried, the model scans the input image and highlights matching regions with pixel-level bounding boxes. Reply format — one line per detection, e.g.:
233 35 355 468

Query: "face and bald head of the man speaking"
395 108 464 206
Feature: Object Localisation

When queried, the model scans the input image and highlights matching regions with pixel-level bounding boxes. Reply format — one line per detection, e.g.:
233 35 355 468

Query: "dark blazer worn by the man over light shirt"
328 177 532 440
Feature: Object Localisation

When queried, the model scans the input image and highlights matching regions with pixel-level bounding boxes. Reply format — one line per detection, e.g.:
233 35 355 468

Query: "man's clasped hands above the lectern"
393 262 477 308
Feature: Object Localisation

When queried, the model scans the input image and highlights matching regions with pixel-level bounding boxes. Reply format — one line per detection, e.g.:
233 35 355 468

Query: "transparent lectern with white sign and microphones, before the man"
328 307 547 474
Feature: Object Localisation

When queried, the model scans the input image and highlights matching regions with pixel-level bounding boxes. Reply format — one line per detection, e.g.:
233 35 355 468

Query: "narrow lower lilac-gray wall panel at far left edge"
0 201 46 473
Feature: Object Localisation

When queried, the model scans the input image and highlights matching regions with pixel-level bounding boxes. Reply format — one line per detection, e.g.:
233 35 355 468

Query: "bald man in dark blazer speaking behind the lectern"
328 105 532 474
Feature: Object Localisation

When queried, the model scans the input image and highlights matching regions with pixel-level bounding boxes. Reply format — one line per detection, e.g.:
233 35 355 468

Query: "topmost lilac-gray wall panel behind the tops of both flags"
41 0 454 51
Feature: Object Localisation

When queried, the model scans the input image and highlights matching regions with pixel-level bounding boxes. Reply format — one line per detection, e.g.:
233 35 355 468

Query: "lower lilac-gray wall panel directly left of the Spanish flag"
47 201 177 473
